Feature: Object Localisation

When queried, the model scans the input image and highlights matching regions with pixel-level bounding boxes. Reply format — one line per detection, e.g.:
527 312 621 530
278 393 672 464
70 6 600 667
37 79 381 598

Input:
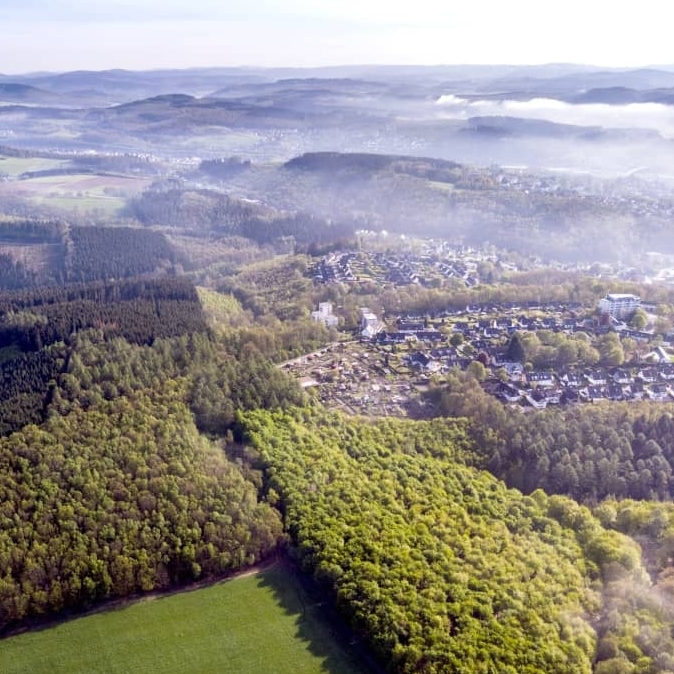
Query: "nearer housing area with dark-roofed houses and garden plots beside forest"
296 294 674 416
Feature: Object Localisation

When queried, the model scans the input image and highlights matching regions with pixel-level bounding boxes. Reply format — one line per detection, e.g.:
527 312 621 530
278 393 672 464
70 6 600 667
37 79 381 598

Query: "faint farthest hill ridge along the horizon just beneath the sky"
5 64 674 102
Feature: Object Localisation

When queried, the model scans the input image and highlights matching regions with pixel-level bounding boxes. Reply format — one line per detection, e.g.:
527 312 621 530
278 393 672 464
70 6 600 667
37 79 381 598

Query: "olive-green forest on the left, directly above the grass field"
0 322 302 629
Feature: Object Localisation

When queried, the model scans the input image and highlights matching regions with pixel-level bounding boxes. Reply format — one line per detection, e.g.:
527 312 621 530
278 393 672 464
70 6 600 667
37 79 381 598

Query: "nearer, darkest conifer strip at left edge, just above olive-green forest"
0 277 206 351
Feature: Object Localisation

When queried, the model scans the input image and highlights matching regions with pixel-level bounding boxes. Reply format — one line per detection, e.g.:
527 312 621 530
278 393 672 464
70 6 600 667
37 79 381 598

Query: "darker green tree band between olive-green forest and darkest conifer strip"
55 332 304 435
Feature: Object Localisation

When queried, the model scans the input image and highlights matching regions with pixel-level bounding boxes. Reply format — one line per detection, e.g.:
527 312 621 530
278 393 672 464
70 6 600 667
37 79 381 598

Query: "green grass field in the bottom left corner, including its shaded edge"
0 565 370 674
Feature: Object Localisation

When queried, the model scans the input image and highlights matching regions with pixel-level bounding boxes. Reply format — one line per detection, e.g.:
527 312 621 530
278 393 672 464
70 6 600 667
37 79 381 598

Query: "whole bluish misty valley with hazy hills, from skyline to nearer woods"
0 65 674 263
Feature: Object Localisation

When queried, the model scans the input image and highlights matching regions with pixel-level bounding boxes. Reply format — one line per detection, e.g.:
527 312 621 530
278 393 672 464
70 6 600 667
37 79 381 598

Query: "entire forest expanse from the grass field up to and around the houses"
0 228 674 674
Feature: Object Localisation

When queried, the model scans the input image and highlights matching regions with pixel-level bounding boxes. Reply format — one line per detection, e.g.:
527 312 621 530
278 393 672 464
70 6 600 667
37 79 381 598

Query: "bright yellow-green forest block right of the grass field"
237 409 660 674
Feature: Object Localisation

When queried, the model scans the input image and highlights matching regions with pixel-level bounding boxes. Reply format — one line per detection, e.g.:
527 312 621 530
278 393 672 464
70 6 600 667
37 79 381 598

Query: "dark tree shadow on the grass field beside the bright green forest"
257 556 384 674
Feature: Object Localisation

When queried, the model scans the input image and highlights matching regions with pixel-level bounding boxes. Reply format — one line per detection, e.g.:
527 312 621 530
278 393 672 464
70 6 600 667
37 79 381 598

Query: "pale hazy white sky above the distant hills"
0 0 674 73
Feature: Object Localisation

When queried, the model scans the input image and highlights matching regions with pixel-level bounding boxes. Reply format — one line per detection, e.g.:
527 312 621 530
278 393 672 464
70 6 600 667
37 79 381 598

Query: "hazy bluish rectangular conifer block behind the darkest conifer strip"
66 225 175 283
